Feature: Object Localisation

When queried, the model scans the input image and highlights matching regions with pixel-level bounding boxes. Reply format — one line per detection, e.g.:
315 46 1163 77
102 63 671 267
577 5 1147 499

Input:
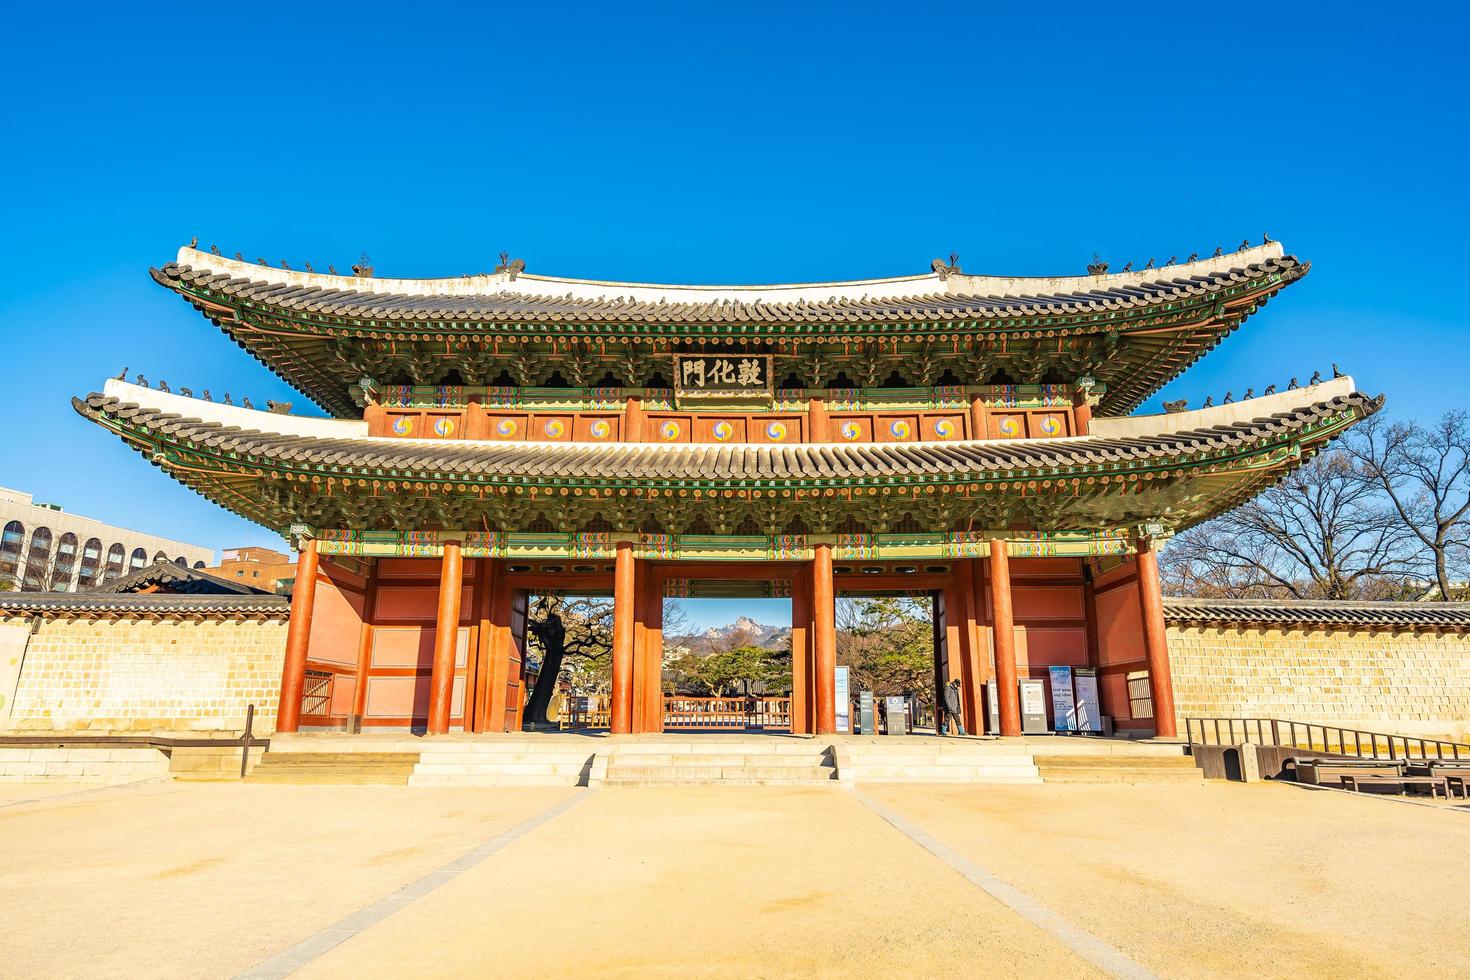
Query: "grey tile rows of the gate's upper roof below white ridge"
150 256 1305 325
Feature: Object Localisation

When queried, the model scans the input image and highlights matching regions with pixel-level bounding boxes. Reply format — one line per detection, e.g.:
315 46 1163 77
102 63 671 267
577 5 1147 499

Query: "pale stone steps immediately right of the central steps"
835 736 1041 785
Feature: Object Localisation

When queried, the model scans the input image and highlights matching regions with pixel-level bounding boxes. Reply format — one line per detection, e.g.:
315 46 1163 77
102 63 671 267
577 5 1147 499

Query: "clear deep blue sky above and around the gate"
0 3 1470 620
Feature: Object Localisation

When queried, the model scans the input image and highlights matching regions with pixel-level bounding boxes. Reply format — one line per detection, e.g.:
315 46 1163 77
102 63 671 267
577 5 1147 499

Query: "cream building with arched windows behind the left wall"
0 486 215 592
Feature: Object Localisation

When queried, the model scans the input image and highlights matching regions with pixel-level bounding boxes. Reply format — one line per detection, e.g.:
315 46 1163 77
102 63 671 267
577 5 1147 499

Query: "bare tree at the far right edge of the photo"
1344 411 1470 601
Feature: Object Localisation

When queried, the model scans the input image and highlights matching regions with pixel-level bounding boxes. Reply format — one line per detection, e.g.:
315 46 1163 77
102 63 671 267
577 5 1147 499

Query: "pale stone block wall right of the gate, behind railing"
1169 623 1470 741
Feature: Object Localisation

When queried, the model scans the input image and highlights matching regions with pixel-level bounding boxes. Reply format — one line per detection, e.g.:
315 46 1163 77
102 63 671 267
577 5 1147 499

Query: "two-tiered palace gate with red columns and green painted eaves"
75 242 1380 736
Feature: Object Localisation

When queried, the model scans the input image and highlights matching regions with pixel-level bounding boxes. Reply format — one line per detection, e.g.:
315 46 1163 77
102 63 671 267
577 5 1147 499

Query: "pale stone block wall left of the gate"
0 616 287 735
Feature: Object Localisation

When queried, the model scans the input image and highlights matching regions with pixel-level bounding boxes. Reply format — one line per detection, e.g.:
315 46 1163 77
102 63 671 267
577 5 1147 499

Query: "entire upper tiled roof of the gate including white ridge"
151 245 1305 325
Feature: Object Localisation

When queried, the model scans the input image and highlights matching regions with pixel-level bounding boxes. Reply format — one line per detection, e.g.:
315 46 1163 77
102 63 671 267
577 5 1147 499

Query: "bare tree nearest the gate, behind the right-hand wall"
1164 449 1416 599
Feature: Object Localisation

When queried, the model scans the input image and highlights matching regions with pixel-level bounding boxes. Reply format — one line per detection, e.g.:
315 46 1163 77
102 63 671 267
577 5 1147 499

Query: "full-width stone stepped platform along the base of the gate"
251 732 1198 788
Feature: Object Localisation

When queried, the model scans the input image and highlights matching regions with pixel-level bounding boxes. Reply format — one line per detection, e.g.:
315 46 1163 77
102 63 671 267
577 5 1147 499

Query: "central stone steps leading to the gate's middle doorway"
592 735 836 786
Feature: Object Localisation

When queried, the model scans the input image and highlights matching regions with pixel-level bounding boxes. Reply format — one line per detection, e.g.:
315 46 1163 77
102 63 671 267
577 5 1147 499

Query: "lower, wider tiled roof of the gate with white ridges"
72 392 1382 480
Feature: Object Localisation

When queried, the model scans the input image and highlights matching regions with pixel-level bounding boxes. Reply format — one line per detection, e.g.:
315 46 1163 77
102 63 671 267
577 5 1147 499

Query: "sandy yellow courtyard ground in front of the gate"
0 783 1470 977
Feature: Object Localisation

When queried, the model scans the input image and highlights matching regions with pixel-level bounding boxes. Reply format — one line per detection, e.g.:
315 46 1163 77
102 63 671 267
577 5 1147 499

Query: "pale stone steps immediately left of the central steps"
409 735 593 786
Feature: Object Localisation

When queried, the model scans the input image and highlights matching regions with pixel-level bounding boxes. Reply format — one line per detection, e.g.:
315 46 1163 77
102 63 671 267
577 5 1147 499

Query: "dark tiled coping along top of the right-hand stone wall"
1164 597 1470 629
